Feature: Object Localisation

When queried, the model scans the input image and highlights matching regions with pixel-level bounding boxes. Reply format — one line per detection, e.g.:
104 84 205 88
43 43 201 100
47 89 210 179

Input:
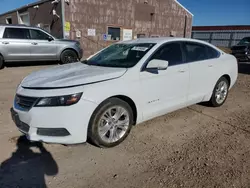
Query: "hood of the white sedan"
21 62 127 89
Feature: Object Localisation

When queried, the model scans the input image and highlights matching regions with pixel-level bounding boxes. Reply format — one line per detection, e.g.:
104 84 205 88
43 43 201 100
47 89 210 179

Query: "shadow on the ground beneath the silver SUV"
5 61 59 68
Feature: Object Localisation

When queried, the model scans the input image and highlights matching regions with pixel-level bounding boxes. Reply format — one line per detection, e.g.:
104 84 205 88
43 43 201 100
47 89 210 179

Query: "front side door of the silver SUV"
29 29 57 61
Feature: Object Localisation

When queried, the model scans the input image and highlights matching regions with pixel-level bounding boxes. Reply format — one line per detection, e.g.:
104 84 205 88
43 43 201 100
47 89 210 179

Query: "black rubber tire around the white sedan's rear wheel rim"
209 77 229 107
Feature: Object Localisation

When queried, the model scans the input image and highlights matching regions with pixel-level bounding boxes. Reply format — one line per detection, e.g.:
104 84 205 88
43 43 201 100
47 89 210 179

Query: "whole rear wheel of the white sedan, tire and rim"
210 77 229 107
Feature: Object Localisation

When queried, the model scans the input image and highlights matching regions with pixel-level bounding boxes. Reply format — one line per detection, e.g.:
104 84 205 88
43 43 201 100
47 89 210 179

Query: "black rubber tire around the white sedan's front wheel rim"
88 98 134 148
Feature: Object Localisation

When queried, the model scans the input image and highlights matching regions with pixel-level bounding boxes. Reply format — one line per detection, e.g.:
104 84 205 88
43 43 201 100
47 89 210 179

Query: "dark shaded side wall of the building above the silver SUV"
0 1 63 38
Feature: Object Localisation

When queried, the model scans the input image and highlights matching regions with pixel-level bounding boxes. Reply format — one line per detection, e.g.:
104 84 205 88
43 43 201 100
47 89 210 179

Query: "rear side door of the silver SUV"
0 27 31 61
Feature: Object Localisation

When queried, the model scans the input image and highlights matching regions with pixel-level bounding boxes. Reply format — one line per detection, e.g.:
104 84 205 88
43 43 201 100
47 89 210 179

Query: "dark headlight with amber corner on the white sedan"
35 93 82 107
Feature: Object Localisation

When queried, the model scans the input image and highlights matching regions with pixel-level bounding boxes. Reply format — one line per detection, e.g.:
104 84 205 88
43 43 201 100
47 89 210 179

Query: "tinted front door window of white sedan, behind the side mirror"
151 43 183 66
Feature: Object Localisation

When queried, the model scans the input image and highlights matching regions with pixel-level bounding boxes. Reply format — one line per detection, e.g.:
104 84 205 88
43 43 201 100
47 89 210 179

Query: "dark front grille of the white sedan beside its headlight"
15 95 38 111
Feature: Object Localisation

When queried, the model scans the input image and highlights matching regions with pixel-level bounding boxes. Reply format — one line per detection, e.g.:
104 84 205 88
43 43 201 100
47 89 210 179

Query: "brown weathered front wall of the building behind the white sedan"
65 0 192 57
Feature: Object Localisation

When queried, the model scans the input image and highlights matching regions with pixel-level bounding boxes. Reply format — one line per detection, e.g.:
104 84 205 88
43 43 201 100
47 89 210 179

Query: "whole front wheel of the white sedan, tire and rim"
88 98 133 148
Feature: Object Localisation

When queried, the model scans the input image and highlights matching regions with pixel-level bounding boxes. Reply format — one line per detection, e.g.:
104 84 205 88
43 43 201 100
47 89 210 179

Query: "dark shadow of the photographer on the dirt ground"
0 136 58 188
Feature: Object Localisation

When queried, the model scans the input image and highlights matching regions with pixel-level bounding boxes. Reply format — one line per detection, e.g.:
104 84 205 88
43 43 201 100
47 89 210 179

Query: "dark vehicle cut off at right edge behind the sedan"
231 37 250 61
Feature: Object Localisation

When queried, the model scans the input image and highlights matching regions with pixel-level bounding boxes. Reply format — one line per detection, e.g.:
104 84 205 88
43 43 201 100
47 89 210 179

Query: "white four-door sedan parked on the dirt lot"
11 38 238 147
